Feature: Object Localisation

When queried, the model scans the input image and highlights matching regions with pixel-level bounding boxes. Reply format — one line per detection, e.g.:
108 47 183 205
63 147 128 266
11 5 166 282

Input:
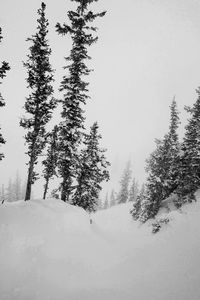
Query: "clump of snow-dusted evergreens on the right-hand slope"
131 94 200 222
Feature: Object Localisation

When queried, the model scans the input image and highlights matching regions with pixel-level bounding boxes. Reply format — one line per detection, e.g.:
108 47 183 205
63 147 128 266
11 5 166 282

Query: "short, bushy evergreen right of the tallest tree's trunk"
72 122 110 212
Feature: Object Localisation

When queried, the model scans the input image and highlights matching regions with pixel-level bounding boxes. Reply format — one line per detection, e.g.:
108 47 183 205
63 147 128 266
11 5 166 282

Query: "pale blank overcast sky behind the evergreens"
0 0 200 196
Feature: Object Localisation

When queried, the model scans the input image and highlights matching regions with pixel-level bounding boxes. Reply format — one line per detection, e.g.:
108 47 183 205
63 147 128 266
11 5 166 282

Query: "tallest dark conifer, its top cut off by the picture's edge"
56 0 105 201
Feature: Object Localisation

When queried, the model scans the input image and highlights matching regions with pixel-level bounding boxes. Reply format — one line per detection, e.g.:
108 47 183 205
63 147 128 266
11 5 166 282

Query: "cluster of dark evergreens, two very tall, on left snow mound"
0 0 109 212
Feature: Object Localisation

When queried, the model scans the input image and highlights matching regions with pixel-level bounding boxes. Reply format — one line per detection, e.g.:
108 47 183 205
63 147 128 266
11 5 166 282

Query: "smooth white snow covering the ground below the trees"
0 193 200 300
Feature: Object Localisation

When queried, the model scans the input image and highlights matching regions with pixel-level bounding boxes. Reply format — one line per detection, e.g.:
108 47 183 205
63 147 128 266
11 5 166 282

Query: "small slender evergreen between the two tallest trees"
42 125 58 199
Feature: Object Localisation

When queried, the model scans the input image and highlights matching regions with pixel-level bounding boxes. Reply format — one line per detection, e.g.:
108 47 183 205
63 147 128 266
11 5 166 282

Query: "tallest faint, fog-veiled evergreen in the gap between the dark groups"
117 161 131 203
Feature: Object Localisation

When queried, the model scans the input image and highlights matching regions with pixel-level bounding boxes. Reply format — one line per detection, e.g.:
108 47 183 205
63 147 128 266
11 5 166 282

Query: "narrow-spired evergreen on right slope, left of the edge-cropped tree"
140 99 180 222
